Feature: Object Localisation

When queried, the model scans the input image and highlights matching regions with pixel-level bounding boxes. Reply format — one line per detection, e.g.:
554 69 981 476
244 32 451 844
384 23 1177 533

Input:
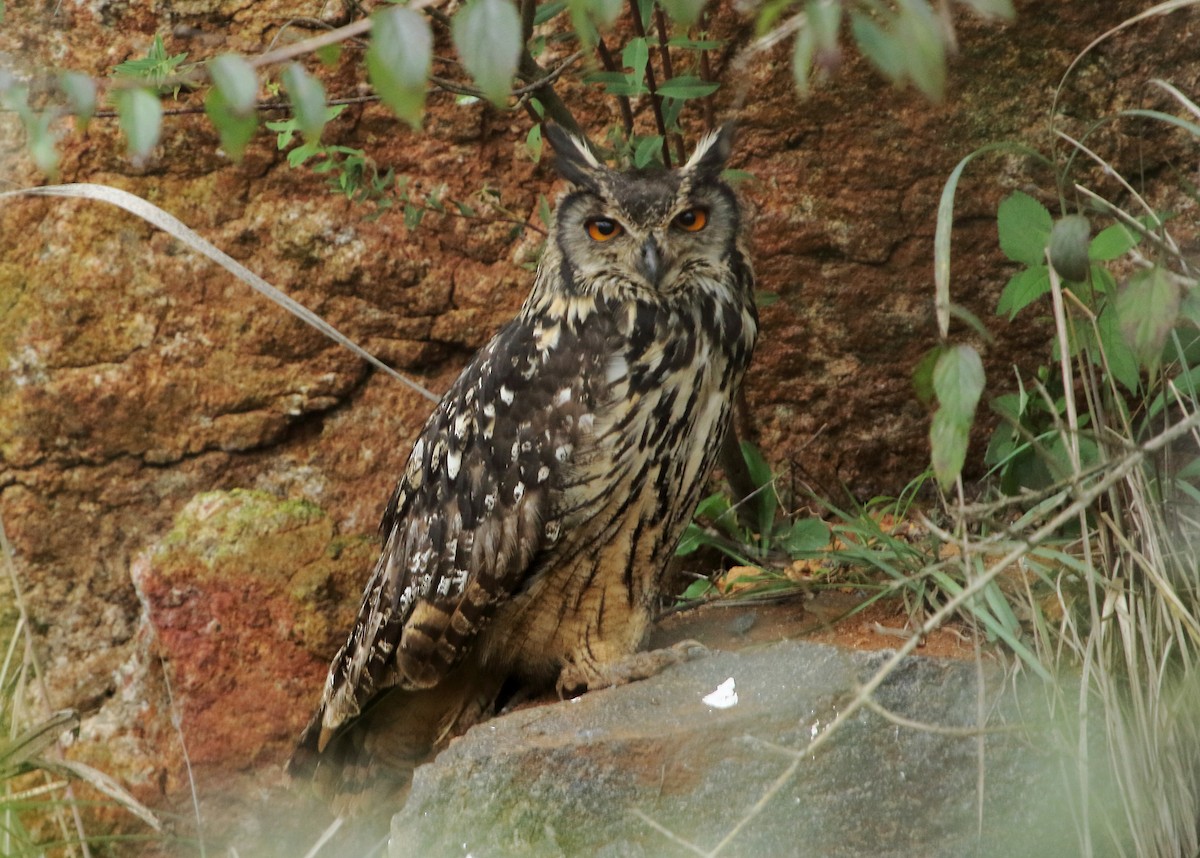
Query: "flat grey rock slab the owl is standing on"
389 642 1099 858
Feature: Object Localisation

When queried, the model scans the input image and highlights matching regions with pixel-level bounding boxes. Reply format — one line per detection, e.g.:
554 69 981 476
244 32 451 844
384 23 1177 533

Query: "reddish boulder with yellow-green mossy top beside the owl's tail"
121 490 376 856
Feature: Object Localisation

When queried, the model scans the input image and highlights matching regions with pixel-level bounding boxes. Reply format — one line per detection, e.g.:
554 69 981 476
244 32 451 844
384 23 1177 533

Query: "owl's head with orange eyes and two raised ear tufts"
544 124 740 293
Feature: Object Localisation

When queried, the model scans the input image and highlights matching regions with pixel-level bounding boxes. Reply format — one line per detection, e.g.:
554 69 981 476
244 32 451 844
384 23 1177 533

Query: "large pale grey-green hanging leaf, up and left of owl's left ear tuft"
452 0 521 107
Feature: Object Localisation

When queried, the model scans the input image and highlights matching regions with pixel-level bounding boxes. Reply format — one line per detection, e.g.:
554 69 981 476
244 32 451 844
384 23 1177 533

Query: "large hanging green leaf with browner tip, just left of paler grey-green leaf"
366 7 439 128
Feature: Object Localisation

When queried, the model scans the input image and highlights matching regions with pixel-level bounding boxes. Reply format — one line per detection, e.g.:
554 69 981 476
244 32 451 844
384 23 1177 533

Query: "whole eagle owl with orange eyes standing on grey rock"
289 125 757 810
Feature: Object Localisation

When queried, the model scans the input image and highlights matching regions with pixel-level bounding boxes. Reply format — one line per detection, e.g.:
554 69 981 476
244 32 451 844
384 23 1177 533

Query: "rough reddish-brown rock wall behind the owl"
0 0 1200 844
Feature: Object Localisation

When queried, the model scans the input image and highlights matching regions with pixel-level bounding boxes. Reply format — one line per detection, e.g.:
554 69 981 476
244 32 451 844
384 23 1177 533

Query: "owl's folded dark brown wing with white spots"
301 317 604 752
